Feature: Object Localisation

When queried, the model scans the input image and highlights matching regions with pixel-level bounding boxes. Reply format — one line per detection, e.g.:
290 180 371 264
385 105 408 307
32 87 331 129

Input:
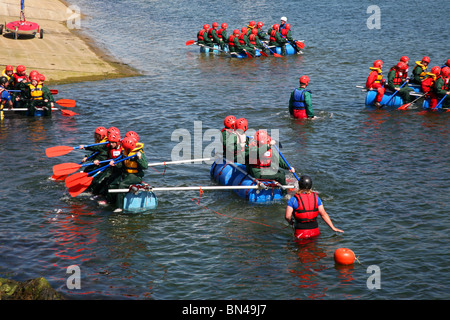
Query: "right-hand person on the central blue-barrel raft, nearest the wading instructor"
246 130 295 185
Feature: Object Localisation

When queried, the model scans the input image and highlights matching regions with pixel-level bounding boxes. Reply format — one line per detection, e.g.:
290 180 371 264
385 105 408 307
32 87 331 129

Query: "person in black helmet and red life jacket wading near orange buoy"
285 175 344 239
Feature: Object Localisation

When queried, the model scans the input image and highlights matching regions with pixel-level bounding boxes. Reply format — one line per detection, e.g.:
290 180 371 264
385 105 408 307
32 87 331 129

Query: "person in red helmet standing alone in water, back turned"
289 75 315 119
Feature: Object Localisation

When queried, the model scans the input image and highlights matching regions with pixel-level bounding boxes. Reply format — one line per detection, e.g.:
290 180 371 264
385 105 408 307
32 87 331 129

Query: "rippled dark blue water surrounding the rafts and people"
0 0 450 300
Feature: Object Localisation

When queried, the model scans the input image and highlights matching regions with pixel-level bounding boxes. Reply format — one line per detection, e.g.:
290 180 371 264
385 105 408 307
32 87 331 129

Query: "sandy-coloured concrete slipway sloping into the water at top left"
0 0 142 85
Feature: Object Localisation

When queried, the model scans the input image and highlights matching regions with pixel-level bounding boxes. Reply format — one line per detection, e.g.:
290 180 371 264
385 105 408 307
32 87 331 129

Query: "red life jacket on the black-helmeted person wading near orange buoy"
294 192 319 229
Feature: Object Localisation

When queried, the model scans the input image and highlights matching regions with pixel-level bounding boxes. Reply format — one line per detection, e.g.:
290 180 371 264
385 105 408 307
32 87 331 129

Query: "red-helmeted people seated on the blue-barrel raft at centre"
222 115 295 185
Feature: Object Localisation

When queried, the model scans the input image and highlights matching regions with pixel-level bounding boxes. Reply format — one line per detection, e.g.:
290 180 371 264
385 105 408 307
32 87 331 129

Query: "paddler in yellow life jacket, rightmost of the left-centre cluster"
110 137 148 212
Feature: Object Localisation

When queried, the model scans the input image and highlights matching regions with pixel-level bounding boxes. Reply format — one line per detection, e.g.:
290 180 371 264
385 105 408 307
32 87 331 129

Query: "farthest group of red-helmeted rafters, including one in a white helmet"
197 17 300 57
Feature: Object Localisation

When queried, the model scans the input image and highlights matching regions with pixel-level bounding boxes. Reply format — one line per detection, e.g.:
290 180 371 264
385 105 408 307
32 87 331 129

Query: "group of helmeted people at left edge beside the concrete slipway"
0 65 55 116
